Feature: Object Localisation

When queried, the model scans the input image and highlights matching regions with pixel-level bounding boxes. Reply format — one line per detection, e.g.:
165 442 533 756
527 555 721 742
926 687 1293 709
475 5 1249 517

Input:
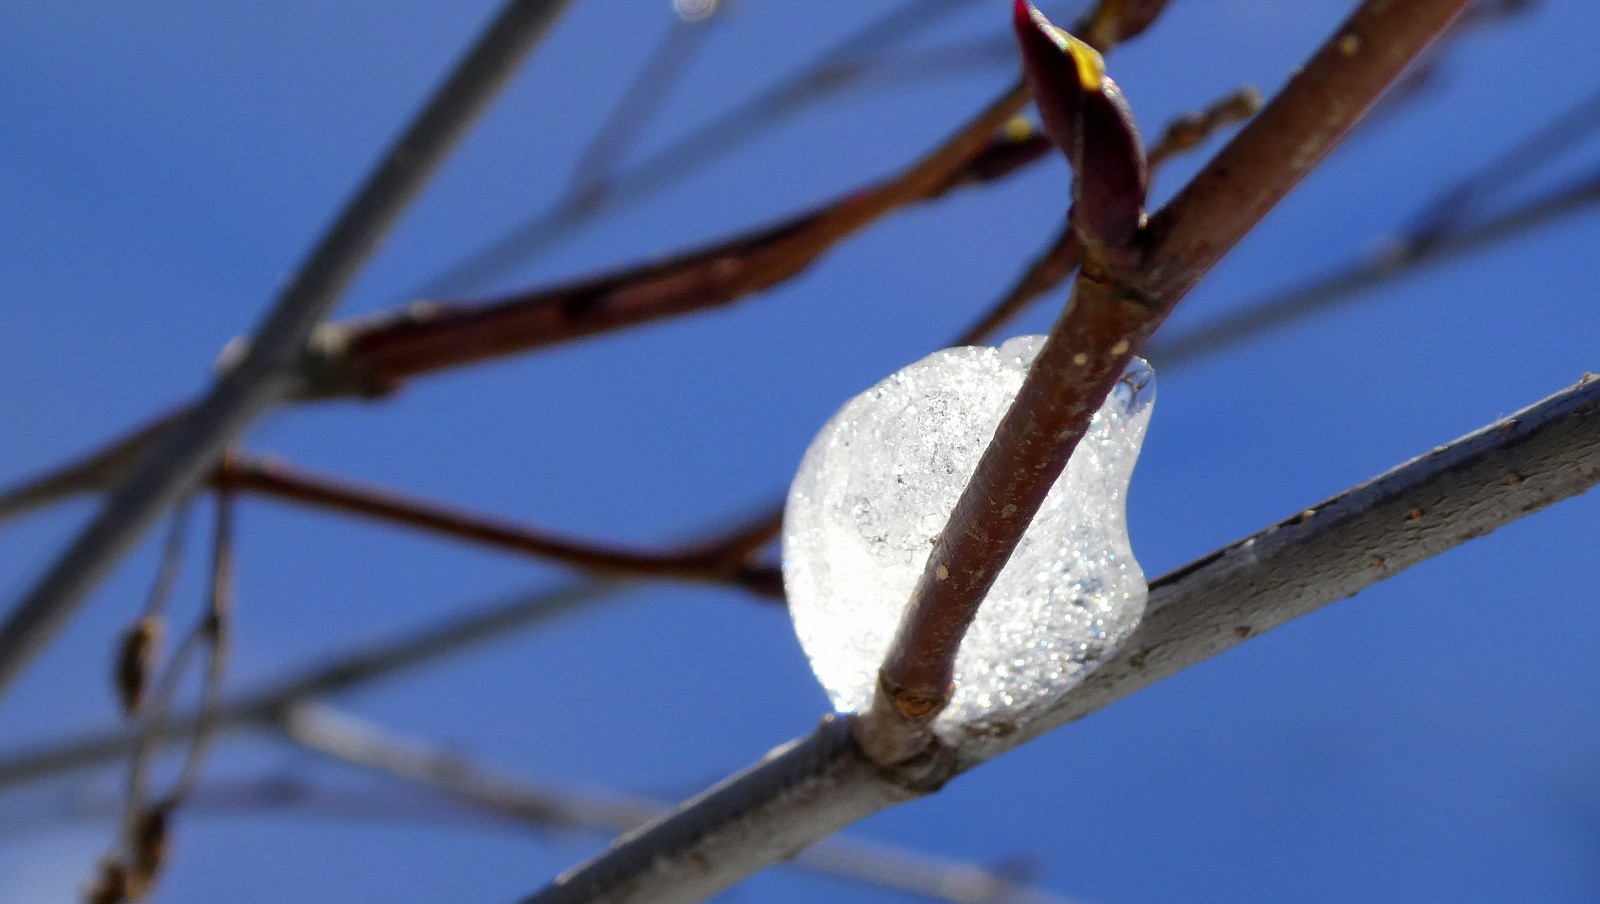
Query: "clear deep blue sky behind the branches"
0 0 1600 904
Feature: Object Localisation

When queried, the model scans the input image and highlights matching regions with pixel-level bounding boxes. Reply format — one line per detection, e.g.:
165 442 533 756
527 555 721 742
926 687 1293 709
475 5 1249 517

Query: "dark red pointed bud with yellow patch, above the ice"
1014 0 1149 250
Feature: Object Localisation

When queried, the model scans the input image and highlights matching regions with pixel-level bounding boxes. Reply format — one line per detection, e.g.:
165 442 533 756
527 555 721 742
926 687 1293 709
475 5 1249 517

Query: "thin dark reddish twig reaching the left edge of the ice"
213 456 782 600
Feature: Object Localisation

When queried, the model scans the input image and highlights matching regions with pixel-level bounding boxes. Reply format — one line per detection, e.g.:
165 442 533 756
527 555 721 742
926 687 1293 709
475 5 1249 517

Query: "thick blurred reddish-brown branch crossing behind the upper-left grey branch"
0 0 1177 522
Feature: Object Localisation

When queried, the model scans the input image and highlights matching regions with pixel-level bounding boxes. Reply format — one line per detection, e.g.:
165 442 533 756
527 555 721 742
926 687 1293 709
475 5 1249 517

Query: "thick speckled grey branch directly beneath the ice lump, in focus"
526 369 1600 904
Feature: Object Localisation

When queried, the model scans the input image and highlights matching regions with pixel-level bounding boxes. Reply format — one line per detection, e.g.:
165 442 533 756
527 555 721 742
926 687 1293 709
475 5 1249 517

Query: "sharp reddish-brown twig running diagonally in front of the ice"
858 0 1467 762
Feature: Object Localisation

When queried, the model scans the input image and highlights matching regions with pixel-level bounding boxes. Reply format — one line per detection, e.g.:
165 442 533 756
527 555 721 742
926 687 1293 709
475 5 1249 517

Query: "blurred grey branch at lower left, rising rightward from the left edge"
0 579 637 789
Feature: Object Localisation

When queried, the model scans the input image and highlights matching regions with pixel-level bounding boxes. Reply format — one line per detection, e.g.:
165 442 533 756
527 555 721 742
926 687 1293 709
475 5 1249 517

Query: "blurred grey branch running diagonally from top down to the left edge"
0 0 582 693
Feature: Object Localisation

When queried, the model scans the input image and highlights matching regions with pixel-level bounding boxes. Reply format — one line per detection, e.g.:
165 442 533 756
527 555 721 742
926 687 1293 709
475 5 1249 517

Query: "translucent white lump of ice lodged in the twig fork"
784 336 1155 741
